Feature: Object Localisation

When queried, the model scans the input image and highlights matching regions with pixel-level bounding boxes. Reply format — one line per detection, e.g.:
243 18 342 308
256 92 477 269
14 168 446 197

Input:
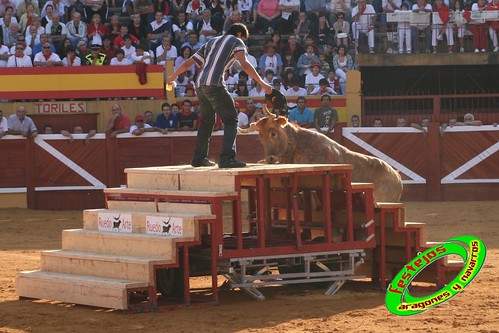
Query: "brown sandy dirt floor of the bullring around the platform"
0 202 499 333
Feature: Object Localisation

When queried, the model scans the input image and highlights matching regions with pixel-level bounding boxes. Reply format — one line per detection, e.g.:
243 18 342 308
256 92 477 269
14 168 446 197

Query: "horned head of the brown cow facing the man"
239 104 291 164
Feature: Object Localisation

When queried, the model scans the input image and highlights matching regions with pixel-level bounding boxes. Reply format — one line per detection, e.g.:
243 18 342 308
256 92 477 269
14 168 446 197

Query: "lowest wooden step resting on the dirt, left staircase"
16 271 148 310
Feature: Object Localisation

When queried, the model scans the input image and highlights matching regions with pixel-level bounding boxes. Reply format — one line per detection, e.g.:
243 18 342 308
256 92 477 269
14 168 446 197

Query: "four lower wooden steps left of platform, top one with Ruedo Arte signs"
16 196 215 311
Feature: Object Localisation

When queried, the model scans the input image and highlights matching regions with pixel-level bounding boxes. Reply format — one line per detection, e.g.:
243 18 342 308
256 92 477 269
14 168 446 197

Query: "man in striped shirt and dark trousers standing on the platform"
166 23 272 168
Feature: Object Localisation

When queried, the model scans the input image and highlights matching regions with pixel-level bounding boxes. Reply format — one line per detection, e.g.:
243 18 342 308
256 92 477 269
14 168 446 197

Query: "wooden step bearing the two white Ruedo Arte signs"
83 209 216 233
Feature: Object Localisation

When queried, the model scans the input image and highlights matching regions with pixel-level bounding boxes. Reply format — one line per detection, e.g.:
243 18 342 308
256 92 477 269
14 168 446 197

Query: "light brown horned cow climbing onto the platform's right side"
240 110 402 202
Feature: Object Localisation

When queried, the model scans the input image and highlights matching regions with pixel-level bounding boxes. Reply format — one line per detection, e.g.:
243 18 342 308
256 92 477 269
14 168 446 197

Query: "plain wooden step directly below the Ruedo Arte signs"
62 229 195 260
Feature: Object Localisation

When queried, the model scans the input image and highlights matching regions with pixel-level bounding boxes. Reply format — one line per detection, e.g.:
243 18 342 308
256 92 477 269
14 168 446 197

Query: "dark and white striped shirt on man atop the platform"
192 35 246 87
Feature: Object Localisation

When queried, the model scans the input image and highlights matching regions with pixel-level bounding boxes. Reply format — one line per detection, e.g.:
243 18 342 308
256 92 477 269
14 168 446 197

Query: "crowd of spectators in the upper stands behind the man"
0 0 499 109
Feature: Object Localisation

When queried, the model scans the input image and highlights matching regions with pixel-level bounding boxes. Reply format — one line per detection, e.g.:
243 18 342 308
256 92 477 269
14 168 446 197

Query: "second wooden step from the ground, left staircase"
40 250 168 286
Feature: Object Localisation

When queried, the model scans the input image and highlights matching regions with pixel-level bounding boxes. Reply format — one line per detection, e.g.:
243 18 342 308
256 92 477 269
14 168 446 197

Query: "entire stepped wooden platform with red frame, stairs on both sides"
16 164 459 311
